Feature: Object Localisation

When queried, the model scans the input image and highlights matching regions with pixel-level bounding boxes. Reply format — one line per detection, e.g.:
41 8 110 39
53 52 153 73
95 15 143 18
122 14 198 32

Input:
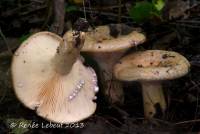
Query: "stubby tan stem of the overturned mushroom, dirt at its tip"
53 32 85 75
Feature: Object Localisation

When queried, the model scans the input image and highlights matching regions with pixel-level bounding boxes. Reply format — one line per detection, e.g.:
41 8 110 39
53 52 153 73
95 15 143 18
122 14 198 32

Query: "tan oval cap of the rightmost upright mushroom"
114 50 190 81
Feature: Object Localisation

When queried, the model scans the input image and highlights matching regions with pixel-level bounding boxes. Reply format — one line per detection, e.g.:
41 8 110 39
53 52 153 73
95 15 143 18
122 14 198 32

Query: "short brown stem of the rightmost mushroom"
141 81 166 118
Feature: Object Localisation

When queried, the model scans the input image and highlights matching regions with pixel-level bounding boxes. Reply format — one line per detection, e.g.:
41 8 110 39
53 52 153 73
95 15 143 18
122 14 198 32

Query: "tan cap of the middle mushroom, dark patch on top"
64 24 146 52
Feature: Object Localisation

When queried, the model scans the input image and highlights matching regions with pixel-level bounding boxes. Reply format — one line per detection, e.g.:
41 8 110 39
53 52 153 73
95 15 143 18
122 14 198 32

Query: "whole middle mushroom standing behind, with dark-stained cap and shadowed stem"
64 24 145 104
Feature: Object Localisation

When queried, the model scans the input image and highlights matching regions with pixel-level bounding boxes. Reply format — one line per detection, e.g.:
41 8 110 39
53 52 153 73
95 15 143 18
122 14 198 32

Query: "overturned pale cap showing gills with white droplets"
12 32 98 123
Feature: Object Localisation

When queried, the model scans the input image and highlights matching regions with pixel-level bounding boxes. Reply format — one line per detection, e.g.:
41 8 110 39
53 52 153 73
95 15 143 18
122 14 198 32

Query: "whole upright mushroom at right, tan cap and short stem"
114 50 190 118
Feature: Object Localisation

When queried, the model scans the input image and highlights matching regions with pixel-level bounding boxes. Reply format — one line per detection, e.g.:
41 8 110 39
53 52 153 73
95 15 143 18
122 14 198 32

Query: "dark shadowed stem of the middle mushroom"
93 51 125 104
